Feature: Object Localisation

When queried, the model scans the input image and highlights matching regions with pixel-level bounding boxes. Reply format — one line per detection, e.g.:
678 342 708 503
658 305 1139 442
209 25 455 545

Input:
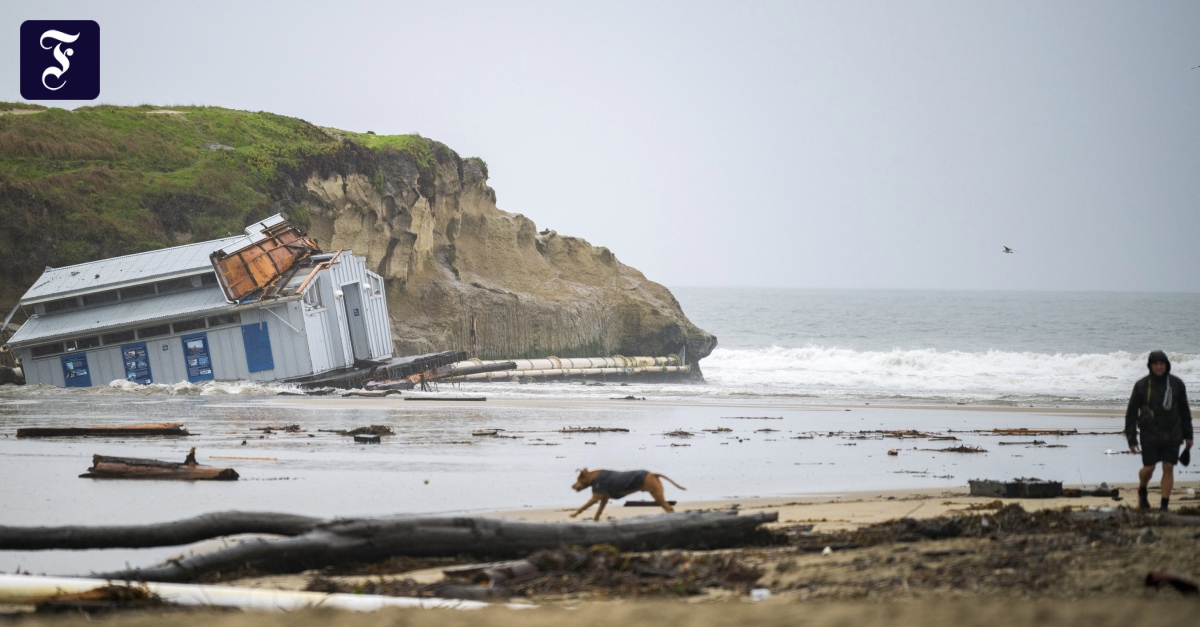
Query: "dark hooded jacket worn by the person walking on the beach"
1124 351 1192 447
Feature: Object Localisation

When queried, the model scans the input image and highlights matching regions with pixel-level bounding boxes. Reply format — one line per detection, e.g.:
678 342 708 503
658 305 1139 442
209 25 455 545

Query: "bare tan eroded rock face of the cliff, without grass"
295 143 716 364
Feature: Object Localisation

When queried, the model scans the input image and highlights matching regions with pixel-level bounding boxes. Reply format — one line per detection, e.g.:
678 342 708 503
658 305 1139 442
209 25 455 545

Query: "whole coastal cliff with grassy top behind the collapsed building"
0 103 716 364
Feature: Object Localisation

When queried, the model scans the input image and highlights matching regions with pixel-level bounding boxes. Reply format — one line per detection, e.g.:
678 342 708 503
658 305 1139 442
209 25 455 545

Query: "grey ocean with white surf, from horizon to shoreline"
672 287 1200 407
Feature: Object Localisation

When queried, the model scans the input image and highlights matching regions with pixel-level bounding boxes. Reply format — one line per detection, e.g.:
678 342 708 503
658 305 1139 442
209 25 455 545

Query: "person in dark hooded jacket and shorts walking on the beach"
1124 351 1192 512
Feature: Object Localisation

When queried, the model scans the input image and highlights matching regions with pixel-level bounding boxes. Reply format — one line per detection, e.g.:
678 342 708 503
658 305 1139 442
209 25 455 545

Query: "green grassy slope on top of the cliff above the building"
0 102 446 316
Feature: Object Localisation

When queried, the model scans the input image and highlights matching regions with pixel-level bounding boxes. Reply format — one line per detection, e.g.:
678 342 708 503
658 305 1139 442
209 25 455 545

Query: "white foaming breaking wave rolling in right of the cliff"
701 345 1200 405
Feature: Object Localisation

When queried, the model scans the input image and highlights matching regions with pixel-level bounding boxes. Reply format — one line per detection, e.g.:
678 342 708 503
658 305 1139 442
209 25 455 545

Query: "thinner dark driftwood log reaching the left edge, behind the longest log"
0 512 325 551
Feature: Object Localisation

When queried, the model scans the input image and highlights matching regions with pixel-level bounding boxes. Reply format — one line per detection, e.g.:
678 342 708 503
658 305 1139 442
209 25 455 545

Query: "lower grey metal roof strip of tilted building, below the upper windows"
8 284 232 347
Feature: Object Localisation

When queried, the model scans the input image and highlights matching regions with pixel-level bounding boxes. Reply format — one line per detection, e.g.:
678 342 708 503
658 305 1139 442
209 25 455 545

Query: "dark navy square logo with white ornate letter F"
20 19 100 100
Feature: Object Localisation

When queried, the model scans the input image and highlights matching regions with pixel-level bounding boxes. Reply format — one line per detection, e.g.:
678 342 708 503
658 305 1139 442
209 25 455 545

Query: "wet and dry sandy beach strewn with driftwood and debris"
0 390 1200 625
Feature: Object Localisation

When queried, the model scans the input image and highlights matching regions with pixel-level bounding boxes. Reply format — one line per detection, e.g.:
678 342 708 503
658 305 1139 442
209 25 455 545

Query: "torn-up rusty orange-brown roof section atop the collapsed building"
209 214 322 303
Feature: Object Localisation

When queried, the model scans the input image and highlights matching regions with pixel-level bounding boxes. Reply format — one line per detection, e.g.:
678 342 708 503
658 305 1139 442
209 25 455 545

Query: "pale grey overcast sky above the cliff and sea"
0 0 1200 292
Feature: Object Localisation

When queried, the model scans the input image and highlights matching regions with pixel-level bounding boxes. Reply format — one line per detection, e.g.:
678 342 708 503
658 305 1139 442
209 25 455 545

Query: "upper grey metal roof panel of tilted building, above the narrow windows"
20 235 247 305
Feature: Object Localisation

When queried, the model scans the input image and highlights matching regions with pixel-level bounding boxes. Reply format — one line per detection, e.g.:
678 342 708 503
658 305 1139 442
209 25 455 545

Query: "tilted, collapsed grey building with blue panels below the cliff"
0 215 398 387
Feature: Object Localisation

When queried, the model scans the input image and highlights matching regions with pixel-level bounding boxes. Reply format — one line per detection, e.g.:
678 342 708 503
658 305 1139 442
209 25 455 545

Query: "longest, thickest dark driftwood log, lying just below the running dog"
98 512 779 583
